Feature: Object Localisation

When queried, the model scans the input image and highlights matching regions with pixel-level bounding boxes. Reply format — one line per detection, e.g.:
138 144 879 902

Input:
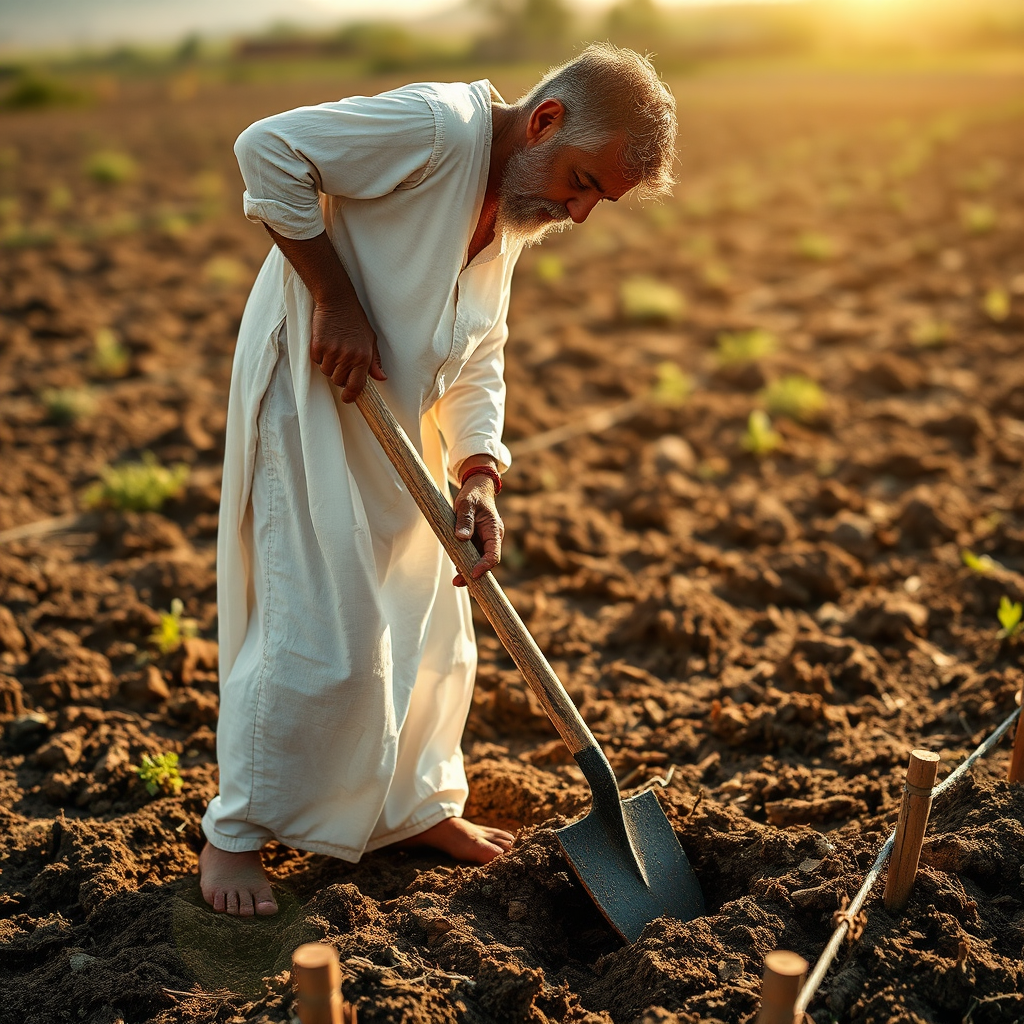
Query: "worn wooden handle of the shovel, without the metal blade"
355 380 597 755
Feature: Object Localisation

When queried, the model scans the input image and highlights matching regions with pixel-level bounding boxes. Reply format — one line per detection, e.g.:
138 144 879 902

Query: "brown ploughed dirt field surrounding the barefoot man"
0 59 1024 1024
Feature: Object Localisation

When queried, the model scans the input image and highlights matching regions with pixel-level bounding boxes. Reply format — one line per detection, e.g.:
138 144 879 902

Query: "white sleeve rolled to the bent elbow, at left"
234 90 442 240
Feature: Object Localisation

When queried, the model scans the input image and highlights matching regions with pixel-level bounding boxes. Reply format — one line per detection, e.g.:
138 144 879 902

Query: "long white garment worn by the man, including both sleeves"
203 81 518 860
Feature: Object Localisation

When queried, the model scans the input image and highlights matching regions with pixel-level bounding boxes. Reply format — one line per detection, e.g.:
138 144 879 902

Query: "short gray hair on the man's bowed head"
512 43 677 199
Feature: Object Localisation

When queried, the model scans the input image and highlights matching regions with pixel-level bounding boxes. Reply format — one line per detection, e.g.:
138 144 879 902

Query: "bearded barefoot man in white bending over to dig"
200 45 676 915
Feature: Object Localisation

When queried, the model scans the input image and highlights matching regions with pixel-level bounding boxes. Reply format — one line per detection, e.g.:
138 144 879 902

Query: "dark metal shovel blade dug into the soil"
555 790 705 942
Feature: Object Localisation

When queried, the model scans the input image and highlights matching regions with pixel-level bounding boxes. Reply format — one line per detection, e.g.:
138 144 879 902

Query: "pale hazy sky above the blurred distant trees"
0 0 790 53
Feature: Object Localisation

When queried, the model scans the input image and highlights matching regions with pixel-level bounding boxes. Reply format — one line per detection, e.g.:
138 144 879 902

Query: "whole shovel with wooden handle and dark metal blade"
356 380 705 942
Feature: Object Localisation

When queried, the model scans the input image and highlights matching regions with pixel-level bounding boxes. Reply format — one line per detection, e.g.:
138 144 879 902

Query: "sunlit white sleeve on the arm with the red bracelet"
436 289 512 483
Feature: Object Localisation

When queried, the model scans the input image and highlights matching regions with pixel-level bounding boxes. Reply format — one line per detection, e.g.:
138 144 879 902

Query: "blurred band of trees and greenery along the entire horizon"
0 0 1024 109
